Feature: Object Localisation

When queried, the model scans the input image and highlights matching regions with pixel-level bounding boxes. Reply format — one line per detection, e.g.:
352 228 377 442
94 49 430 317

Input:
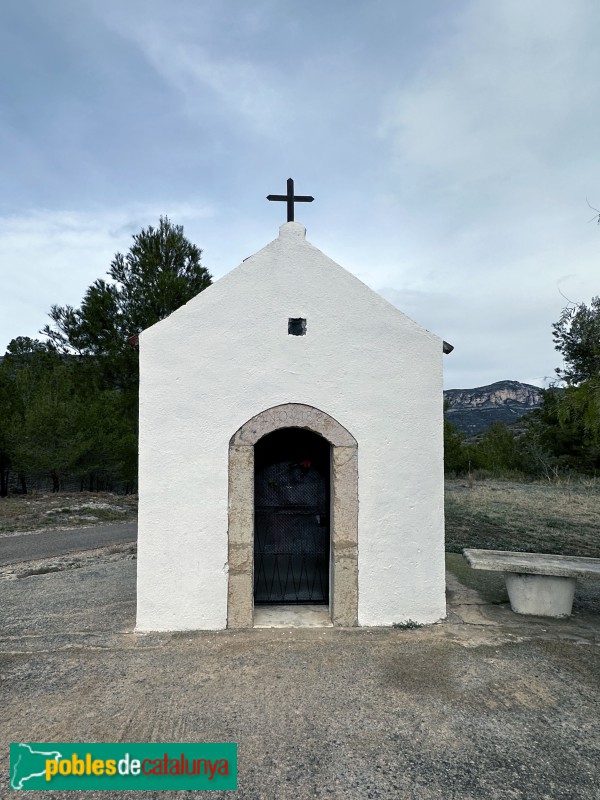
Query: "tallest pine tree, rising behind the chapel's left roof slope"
37 217 212 485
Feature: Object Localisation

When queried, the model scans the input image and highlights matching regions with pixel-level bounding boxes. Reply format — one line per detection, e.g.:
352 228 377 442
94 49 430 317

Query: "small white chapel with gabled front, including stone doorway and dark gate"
136 212 446 631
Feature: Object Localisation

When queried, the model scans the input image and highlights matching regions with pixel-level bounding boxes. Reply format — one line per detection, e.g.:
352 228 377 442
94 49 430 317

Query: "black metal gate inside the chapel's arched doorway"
254 428 330 603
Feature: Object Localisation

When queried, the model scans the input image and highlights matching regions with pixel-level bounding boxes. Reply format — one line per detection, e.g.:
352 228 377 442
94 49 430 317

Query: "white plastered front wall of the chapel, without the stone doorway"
137 223 445 630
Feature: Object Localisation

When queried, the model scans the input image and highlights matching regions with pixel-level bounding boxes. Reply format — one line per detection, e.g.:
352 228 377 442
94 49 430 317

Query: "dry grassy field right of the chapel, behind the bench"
446 478 600 558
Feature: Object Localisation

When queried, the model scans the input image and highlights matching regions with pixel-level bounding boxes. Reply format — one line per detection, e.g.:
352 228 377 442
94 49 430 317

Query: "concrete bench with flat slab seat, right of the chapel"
463 548 600 618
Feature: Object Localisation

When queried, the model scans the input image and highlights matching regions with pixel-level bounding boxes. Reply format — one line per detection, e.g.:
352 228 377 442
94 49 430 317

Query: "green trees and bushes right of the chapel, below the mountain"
444 297 600 479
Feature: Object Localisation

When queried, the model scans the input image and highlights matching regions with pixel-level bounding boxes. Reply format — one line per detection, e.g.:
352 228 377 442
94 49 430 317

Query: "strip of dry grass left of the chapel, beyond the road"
0 492 137 535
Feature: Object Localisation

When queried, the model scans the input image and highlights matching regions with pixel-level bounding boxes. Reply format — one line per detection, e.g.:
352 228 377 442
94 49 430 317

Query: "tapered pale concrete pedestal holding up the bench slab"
504 572 577 619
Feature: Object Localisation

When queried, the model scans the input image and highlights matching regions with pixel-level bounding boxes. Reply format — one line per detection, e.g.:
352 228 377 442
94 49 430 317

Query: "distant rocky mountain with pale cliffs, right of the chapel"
444 381 542 436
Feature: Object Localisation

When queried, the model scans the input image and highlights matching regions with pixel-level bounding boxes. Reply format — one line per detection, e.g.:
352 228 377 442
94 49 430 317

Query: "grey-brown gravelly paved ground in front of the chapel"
0 550 600 800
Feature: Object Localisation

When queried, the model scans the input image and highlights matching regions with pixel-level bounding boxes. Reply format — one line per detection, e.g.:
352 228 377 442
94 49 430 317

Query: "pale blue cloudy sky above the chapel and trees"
0 0 600 388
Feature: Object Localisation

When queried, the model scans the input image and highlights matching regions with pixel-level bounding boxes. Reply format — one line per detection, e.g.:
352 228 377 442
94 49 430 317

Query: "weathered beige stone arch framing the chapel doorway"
227 403 358 628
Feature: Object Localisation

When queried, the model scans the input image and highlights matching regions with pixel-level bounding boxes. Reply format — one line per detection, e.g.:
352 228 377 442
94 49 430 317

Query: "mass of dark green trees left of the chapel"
0 217 212 496
